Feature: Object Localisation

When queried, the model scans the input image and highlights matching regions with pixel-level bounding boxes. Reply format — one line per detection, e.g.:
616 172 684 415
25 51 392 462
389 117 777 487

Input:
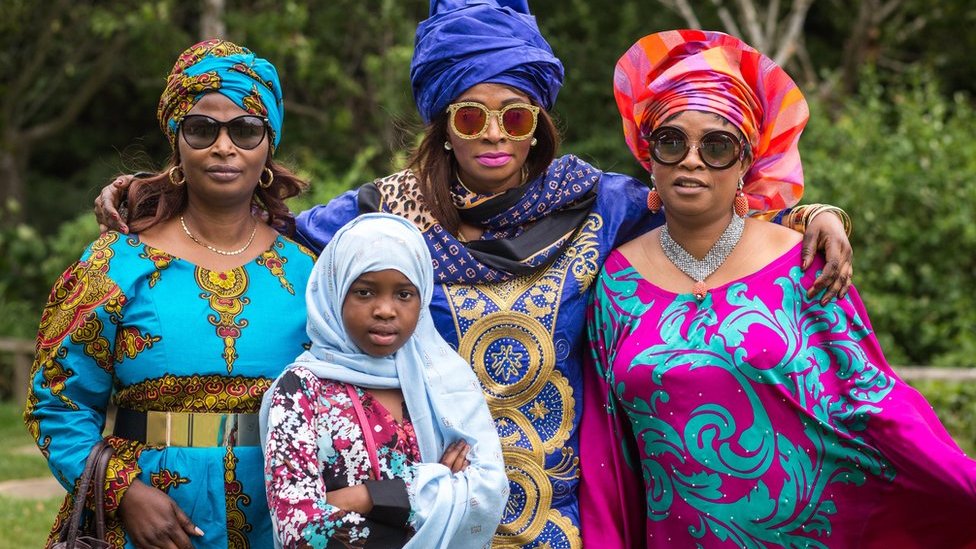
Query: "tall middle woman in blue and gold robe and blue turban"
297 0 849 547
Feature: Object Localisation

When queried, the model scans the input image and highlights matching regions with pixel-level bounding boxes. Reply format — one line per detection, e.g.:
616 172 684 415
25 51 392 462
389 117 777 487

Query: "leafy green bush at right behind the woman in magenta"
801 73 976 366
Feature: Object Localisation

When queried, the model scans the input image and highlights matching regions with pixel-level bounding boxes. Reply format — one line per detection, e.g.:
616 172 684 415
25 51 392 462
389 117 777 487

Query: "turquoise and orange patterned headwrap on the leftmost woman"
156 39 285 151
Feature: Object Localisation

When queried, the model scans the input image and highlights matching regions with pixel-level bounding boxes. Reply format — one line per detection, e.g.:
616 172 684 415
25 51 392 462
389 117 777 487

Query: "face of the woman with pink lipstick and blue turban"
447 83 532 194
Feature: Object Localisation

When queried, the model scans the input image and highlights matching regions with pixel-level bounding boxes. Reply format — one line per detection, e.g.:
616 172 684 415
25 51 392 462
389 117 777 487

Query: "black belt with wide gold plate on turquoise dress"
113 408 261 448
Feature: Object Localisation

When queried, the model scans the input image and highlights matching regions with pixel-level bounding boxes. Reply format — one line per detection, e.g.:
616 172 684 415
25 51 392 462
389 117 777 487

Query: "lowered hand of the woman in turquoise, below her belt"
119 480 203 549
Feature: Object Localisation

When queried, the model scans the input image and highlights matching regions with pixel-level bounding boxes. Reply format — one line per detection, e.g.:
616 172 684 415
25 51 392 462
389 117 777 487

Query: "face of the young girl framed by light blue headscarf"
342 269 420 358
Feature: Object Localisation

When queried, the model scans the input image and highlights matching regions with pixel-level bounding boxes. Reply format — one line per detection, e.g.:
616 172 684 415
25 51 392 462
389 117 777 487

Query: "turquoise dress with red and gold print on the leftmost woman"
25 232 314 548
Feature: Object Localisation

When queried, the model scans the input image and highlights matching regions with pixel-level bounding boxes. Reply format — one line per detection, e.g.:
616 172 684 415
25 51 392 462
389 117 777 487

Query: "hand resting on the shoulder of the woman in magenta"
803 213 854 305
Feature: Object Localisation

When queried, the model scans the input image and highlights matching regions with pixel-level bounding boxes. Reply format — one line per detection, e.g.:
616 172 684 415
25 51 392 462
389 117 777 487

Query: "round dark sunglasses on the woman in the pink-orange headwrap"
647 126 745 170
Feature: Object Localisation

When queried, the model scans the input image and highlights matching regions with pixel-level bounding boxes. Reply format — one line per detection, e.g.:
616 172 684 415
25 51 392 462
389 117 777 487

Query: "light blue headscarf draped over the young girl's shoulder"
255 213 508 547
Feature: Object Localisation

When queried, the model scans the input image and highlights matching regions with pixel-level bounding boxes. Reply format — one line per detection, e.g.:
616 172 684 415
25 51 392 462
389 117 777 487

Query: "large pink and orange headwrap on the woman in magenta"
613 30 810 211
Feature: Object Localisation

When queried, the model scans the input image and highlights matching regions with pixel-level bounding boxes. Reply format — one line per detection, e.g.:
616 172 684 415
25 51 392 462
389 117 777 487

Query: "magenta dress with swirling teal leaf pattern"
580 245 976 548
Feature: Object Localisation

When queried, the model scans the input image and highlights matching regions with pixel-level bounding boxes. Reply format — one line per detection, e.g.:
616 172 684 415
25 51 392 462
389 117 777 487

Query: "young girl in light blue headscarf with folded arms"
261 214 508 548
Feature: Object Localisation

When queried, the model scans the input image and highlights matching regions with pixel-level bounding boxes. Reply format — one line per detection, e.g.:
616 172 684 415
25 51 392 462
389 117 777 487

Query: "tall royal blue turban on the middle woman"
410 0 563 123
